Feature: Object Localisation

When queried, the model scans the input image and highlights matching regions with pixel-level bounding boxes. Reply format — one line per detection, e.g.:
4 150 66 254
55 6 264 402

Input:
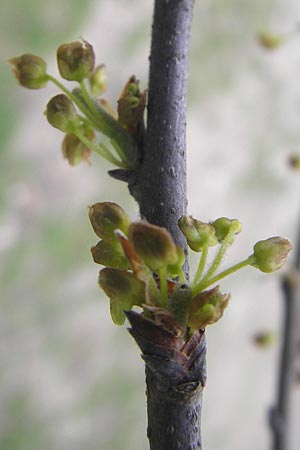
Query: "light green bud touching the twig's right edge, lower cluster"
178 216 218 252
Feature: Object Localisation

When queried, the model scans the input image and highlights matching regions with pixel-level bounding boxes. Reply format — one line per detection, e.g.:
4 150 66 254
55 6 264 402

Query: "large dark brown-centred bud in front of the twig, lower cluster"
128 222 178 271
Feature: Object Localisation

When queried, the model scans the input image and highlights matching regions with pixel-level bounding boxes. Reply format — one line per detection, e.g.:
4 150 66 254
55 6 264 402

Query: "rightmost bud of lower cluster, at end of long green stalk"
251 236 292 273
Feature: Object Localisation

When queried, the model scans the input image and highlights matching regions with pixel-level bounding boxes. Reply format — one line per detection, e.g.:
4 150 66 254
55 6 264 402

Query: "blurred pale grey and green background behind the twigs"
0 0 300 450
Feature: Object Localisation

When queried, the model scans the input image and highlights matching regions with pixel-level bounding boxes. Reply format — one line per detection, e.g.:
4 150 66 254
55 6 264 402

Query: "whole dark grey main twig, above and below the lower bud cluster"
127 0 206 450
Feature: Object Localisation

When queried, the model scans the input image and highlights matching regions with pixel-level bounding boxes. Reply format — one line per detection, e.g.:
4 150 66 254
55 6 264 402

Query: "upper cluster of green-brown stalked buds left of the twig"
9 40 146 169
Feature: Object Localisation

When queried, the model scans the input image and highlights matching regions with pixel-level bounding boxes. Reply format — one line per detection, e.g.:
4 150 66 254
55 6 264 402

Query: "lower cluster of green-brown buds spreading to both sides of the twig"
89 202 291 335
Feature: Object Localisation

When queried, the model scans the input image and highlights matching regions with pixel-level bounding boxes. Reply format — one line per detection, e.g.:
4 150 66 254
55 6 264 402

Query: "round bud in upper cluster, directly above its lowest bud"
46 94 80 133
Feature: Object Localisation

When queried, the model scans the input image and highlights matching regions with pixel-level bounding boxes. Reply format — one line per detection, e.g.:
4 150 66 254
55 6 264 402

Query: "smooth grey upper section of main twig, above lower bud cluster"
134 0 194 248
